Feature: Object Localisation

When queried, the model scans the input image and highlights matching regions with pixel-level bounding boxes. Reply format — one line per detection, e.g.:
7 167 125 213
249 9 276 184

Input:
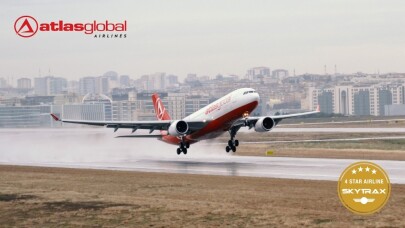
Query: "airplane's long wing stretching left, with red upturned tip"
51 113 208 134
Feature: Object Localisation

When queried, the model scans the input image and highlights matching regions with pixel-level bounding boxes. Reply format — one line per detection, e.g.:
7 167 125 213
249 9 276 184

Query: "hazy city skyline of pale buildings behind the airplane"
0 63 405 127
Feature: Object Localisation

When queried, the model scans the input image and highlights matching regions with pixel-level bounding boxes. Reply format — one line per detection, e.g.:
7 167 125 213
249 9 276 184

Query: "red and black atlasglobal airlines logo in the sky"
14 16 127 38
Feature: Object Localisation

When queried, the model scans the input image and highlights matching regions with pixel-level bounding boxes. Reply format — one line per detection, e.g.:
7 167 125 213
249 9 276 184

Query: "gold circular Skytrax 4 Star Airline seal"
338 161 391 215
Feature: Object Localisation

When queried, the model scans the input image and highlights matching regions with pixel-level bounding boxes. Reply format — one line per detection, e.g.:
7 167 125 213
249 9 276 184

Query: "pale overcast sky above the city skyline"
0 0 405 79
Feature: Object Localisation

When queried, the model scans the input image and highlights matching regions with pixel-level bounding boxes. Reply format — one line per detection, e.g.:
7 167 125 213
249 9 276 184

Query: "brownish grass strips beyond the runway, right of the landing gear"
215 132 405 160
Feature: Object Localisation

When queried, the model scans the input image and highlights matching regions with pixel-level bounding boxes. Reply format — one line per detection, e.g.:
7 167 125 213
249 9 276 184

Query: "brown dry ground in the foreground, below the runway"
0 166 405 227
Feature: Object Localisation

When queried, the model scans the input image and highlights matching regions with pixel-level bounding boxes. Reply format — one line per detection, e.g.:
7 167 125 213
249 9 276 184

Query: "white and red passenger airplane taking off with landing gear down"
51 88 320 154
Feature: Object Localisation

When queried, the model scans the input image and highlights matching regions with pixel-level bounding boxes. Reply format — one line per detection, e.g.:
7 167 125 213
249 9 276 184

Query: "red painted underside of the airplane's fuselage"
162 101 258 145
